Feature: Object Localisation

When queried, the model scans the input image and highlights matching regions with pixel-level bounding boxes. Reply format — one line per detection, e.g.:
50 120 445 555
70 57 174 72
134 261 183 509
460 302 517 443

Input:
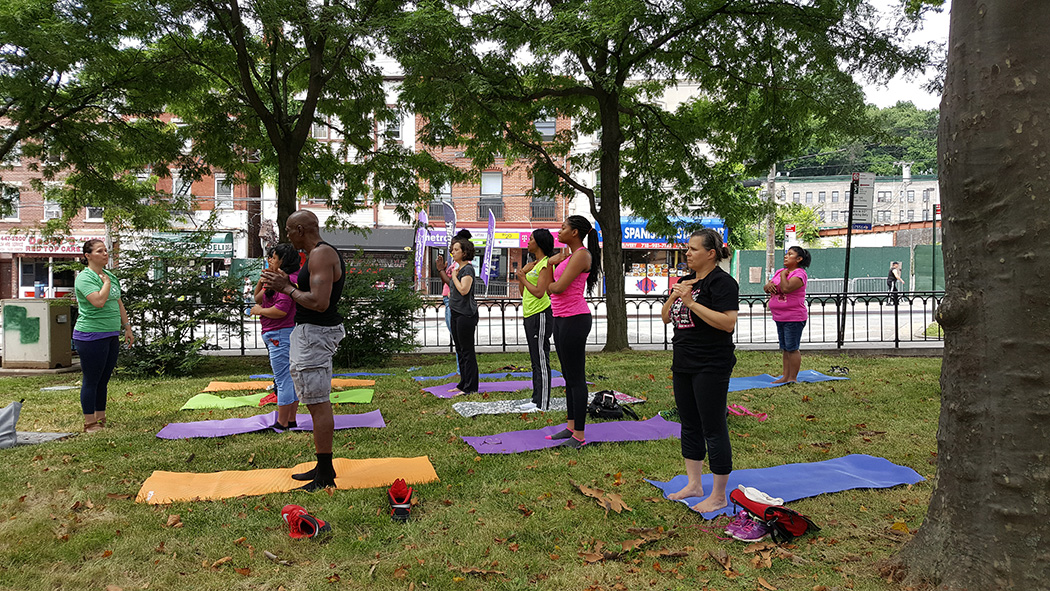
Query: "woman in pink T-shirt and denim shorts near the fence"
762 247 812 384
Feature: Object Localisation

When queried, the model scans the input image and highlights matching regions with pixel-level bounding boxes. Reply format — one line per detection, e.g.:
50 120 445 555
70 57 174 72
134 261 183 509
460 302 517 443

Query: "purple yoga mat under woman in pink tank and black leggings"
463 416 681 453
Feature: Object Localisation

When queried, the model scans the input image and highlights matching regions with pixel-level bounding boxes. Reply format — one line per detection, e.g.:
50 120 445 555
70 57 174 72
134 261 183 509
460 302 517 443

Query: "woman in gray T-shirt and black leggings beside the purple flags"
448 238 479 394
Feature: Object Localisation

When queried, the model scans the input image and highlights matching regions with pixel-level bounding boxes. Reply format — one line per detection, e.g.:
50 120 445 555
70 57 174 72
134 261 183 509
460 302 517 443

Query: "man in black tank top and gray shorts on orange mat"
263 210 347 491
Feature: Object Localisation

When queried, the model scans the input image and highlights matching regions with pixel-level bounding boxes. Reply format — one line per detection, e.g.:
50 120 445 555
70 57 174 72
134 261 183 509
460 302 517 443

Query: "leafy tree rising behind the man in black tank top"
153 0 448 236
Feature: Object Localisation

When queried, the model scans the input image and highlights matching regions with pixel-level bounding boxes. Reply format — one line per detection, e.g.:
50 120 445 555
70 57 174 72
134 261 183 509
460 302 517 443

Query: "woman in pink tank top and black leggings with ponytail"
540 215 602 449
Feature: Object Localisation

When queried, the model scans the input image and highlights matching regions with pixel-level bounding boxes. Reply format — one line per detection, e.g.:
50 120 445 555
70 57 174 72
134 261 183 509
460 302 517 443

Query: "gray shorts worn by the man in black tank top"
289 324 347 404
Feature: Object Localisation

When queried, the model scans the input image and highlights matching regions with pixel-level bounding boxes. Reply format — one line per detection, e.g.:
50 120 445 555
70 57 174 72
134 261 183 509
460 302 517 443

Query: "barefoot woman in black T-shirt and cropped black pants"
660 229 740 513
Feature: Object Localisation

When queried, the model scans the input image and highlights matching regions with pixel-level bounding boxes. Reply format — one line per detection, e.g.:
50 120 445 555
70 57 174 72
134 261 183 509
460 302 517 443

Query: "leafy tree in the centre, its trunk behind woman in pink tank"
394 0 925 350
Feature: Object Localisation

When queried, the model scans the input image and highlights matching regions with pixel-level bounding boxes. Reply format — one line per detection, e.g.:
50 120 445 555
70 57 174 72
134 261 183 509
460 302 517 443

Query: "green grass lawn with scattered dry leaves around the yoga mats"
0 352 941 591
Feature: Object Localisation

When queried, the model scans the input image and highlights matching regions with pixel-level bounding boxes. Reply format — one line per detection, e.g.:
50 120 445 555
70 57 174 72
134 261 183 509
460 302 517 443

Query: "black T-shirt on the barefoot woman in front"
671 267 740 374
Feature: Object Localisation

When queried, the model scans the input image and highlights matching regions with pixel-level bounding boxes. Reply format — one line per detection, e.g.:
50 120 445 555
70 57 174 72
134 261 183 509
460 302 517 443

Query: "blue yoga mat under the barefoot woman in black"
646 453 926 520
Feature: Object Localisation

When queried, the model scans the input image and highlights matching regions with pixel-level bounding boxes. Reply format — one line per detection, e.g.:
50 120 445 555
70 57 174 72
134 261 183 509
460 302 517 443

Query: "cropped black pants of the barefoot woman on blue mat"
672 372 733 474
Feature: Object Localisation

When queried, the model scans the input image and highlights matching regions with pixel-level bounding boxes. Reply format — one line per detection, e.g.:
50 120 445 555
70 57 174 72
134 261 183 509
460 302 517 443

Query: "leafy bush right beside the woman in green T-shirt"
118 231 245 376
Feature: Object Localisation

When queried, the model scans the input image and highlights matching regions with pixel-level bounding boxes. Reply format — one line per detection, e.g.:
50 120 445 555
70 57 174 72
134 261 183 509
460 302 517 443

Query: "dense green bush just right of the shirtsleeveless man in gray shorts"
335 265 423 367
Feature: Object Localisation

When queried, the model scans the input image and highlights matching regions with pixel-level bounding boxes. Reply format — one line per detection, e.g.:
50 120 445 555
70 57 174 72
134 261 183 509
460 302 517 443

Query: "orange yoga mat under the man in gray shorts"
135 456 439 505
